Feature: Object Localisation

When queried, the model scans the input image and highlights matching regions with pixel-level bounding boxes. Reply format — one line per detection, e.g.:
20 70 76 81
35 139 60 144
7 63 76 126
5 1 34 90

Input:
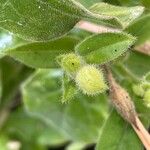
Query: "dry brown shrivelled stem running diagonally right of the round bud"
105 66 150 150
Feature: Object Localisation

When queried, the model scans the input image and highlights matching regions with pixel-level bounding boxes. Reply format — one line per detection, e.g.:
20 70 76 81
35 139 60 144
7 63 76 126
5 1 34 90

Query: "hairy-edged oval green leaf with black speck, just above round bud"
75 33 135 64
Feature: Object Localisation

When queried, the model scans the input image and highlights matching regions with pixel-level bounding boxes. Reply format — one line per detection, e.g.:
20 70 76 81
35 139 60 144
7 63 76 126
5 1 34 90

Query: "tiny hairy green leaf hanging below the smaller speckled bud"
62 74 77 103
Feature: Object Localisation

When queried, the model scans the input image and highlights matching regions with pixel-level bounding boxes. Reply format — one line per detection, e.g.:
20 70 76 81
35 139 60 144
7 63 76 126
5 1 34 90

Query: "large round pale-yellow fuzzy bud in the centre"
75 65 107 95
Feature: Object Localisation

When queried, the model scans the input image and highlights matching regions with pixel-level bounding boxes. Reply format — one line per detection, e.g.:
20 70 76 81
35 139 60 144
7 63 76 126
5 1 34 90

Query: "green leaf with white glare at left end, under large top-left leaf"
0 30 79 68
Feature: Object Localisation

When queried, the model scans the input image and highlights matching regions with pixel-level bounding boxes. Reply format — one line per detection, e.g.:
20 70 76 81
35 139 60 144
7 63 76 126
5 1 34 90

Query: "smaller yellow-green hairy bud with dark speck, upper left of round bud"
57 53 83 74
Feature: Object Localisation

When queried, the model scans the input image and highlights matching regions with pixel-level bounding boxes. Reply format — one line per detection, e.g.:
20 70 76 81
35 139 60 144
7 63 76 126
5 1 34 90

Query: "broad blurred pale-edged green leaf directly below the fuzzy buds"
23 70 107 143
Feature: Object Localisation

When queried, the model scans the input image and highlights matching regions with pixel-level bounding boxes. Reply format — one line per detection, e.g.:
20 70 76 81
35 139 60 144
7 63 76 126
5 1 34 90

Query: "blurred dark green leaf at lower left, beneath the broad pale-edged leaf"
3 108 66 146
